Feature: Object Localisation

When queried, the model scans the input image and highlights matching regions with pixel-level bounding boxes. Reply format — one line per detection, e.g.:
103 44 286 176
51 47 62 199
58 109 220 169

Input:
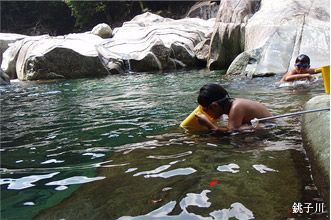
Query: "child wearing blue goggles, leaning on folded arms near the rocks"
280 54 316 82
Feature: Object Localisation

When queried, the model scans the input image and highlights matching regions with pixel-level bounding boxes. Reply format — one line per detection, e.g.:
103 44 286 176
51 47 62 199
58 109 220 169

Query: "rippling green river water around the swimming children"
0 70 328 219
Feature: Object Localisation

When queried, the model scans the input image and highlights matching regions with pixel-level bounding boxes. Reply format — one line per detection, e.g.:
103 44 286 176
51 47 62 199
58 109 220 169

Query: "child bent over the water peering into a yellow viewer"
195 83 272 133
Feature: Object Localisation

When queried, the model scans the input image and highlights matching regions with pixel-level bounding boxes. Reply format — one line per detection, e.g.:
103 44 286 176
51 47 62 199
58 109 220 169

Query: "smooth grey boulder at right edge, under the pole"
302 95 330 211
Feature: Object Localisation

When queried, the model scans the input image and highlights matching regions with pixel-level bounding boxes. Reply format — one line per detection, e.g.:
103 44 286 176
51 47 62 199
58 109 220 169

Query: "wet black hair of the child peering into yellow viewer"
198 83 232 108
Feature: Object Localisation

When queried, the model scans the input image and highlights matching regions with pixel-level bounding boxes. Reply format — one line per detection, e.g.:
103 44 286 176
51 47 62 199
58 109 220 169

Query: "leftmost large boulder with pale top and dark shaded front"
1 34 108 80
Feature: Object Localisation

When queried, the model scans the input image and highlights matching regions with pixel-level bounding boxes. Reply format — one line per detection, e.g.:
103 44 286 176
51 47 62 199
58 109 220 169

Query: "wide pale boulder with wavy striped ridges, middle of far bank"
98 12 215 72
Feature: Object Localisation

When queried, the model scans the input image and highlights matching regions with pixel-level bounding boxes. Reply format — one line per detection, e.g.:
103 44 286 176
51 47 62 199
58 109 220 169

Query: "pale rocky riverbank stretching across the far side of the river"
0 0 330 80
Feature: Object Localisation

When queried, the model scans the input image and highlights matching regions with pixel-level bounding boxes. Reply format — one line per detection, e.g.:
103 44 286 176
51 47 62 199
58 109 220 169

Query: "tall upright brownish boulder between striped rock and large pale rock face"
207 0 260 69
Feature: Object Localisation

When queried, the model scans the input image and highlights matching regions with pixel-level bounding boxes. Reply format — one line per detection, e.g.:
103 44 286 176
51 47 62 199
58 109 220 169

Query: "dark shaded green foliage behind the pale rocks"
0 0 195 35
